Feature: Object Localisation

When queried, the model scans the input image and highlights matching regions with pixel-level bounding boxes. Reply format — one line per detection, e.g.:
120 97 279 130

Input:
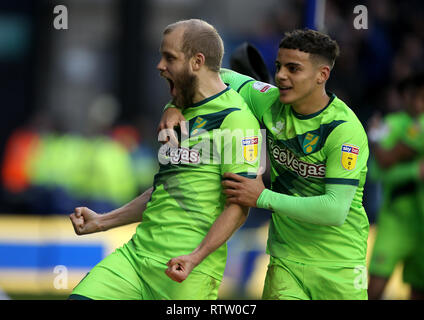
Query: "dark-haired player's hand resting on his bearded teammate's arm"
222 172 265 207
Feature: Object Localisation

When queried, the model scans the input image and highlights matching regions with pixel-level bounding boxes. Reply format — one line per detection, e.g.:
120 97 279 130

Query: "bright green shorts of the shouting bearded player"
70 244 220 300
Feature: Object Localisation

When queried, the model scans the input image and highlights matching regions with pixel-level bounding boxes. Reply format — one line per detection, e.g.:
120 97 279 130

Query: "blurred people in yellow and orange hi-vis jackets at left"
1 114 158 214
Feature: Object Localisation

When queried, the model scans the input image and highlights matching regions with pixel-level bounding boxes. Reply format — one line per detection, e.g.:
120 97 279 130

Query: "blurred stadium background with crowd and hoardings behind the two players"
0 0 424 299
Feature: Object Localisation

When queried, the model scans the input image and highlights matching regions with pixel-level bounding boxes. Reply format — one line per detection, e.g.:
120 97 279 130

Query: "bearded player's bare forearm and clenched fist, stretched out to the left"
69 187 153 235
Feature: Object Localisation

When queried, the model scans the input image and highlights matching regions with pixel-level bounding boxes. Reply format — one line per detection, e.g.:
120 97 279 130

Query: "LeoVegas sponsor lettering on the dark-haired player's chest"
268 137 325 178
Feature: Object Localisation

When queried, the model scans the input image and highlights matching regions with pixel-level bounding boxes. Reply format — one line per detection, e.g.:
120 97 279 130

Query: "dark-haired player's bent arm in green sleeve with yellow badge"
258 121 369 226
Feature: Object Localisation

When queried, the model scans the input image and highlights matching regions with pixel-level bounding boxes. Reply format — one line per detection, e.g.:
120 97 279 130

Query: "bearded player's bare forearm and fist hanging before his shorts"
165 204 248 282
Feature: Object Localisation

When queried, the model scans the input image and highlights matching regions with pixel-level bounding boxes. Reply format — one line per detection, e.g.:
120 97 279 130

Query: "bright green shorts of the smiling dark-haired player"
262 256 368 300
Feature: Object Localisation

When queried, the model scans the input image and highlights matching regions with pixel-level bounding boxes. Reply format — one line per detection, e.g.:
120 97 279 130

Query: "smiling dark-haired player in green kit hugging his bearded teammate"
161 29 369 300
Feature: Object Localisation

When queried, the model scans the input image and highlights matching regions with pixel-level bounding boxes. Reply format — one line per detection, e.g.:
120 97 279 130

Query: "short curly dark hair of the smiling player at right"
279 29 340 68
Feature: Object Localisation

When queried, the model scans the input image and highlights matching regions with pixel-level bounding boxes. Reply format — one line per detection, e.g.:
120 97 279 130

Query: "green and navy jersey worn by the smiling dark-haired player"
221 70 369 266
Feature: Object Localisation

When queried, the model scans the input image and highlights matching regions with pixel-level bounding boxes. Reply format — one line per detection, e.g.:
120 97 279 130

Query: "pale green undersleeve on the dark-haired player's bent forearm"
257 184 357 226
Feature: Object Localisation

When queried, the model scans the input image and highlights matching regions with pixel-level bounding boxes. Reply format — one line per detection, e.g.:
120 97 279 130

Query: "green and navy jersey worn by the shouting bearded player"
132 87 261 280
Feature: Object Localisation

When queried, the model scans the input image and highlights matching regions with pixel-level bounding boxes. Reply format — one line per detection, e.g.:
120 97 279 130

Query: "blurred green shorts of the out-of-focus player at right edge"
369 196 420 278
